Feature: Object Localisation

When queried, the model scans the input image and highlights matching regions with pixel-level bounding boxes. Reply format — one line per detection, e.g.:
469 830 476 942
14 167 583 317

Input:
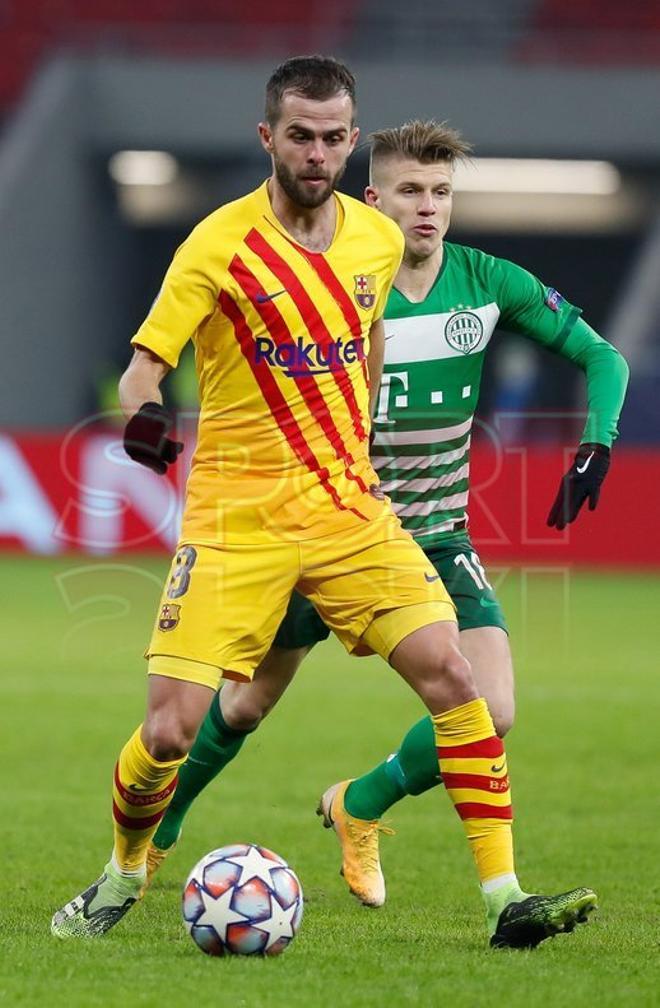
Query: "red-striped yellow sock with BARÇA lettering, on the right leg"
432 698 516 885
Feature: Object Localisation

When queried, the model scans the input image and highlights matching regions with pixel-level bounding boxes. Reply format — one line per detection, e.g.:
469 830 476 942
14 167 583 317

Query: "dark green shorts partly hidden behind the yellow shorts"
273 532 508 649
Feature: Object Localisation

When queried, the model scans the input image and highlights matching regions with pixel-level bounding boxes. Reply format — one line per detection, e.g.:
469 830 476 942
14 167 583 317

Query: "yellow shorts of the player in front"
146 513 455 689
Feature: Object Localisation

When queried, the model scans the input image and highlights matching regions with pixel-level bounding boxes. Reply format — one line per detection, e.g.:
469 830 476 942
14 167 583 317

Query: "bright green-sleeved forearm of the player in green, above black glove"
560 319 629 448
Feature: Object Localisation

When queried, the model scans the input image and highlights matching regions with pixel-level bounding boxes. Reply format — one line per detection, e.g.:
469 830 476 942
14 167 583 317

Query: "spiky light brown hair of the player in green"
369 119 472 178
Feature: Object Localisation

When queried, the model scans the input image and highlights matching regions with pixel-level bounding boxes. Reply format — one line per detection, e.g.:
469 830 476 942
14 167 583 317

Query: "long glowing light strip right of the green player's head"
454 157 621 196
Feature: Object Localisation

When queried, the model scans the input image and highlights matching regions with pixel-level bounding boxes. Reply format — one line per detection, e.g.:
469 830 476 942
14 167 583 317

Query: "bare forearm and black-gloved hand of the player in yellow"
119 347 183 476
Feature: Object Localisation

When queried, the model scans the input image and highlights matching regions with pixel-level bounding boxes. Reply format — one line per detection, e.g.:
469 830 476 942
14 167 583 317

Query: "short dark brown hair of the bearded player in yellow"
266 55 356 126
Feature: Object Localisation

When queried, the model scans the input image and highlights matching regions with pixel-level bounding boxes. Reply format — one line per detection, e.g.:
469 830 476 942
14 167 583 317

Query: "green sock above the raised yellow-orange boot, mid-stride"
344 718 440 820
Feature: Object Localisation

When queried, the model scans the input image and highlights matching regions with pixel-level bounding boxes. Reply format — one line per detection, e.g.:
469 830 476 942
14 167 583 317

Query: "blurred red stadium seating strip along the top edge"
0 0 660 114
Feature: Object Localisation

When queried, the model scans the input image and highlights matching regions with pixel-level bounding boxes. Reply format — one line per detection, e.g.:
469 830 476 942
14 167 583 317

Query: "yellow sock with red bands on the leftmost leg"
112 725 185 872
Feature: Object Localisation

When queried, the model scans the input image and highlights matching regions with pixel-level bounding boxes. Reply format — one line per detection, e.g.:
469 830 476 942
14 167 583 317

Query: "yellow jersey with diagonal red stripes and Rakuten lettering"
132 182 403 543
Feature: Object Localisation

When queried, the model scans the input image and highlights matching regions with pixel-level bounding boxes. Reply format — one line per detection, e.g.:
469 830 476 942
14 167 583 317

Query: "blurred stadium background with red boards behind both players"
0 0 660 565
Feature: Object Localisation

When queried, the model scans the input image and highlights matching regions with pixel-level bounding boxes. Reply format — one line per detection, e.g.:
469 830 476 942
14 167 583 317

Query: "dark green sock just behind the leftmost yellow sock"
153 694 250 851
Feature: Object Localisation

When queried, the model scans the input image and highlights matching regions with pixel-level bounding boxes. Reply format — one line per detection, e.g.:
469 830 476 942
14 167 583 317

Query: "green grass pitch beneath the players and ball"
0 556 660 1008
